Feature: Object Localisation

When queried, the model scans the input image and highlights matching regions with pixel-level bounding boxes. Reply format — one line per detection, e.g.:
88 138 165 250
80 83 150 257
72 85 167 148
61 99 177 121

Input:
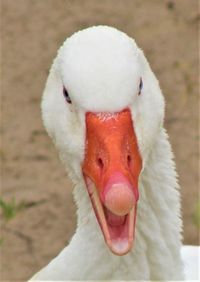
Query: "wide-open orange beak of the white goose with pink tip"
82 109 142 255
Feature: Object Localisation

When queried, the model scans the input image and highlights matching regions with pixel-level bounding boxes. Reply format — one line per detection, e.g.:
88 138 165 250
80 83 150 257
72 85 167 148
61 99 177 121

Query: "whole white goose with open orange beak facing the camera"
31 26 198 281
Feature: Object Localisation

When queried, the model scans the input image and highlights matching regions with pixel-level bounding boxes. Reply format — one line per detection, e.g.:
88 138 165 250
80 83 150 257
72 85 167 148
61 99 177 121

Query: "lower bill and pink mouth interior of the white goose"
85 177 136 256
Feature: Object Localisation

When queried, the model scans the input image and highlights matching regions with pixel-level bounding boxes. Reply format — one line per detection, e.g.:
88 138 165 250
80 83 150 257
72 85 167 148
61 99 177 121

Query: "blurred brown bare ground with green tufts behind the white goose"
0 0 200 281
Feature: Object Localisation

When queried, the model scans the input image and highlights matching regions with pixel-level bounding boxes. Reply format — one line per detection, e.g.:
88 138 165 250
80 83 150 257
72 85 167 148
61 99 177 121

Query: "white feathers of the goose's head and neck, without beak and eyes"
29 26 197 281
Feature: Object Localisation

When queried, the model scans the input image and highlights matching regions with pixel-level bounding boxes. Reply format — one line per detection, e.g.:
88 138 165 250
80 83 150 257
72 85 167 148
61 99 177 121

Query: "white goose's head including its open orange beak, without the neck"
42 26 164 255
